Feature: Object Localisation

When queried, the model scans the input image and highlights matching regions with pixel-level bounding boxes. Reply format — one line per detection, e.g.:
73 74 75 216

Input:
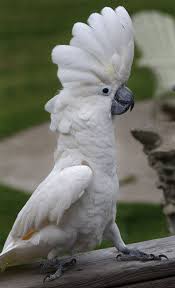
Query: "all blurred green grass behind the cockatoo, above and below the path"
0 0 175 247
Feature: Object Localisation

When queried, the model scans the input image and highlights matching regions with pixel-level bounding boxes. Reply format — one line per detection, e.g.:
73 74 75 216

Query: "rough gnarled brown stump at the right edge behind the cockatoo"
131 122 175 234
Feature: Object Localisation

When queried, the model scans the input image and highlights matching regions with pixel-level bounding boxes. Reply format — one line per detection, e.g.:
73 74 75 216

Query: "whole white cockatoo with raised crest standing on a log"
0 7 165 281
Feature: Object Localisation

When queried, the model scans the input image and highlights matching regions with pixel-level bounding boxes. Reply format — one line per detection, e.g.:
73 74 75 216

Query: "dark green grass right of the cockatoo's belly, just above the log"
99 203 169 248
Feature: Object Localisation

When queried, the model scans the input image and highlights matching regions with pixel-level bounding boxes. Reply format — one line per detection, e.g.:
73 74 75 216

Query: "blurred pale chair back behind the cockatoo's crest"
133 11 175 96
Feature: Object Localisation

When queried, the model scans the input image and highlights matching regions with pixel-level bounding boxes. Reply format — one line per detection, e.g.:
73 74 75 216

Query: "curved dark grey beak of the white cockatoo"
111 85 134 115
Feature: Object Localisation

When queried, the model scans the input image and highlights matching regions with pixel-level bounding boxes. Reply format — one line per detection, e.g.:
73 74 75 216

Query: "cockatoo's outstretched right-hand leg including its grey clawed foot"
108 223 168 262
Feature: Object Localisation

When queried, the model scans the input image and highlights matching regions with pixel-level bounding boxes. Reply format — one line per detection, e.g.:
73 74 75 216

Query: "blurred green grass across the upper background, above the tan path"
0 0 175 138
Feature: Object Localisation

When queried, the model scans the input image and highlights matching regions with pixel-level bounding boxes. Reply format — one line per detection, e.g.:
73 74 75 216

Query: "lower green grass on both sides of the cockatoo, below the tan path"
0 186 168 250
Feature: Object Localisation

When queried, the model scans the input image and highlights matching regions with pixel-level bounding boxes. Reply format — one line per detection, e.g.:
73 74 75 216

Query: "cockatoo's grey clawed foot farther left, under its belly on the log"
43 258 76 282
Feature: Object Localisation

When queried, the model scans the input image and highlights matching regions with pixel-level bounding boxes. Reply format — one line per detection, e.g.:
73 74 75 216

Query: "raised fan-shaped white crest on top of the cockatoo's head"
52 7 134 87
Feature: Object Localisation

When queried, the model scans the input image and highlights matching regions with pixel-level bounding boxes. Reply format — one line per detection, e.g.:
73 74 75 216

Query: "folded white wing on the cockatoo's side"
7 165 92 242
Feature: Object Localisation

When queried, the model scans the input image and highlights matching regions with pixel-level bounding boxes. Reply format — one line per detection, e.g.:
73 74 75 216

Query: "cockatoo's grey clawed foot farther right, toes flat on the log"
116 248 168 262
